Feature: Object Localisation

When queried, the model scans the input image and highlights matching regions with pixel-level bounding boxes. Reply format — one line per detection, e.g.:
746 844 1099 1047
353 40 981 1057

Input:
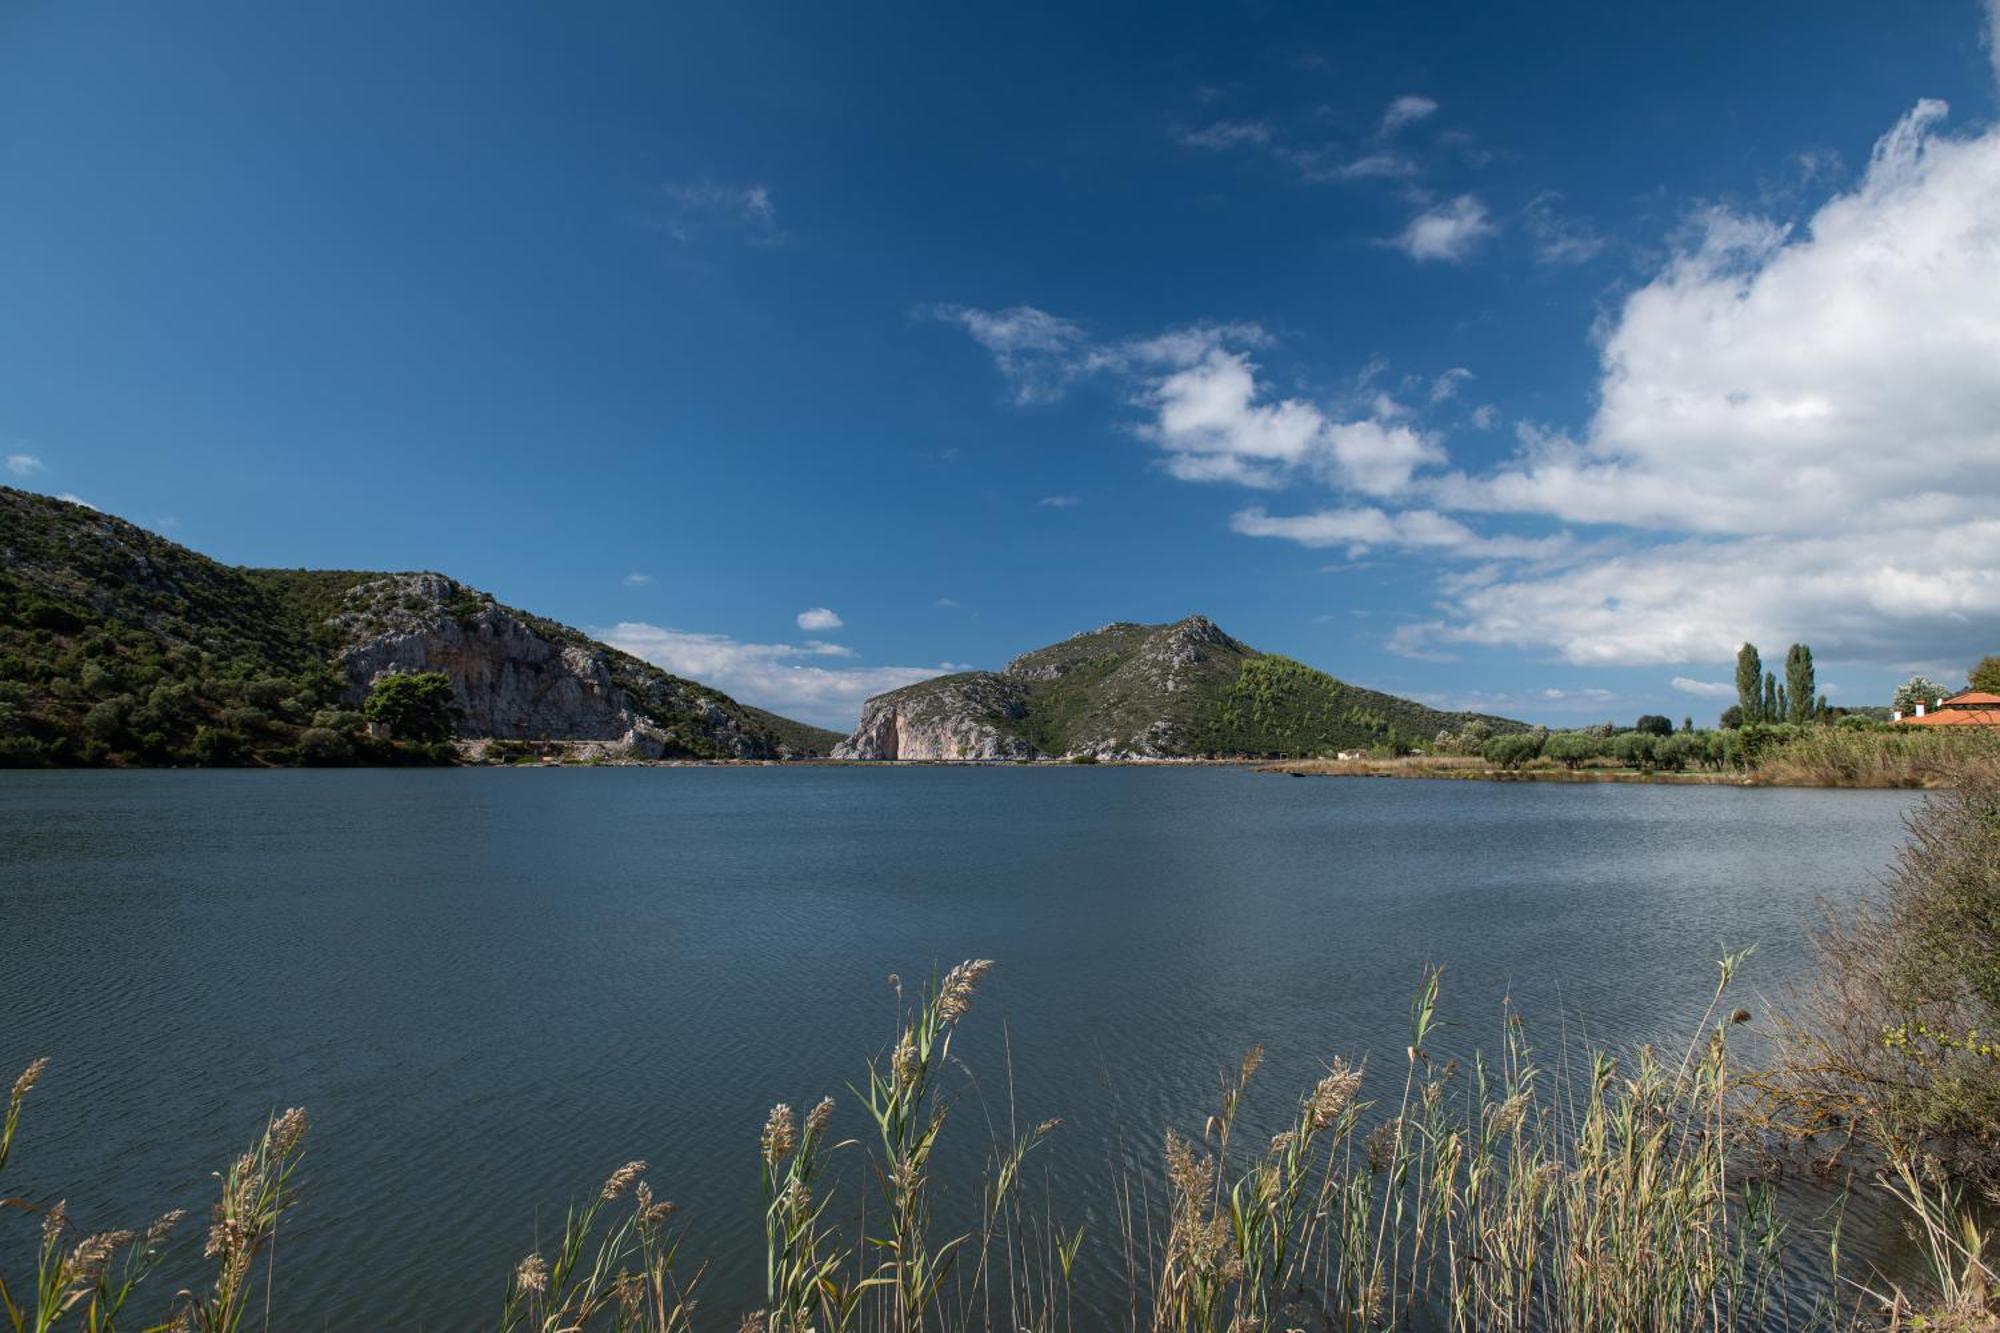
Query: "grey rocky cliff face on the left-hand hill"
328 574 784 759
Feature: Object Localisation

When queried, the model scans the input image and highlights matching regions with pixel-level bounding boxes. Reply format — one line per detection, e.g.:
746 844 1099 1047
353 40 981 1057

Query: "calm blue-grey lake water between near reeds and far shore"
0 767 1912 1329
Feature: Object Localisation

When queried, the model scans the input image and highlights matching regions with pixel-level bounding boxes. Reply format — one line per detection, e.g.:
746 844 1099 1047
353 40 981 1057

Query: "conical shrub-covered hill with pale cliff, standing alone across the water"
834 616 1528 759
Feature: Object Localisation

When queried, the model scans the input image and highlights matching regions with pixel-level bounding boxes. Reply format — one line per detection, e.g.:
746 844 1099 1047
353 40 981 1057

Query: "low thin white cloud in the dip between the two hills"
590 620 962 731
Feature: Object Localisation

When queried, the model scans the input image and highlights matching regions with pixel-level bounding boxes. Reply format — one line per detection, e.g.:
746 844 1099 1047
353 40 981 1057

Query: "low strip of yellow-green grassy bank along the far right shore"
1258 727 2000 791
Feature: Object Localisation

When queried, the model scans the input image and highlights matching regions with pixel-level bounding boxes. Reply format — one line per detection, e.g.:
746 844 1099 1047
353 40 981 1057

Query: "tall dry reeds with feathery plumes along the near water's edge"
0 957 1996 1333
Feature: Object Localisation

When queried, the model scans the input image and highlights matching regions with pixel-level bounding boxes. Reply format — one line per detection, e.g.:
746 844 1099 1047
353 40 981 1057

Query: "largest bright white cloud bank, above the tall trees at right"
1406 102 2000 664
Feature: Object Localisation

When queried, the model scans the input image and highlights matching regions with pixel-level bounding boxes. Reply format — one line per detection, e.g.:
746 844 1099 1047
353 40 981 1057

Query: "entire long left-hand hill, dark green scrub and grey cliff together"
0 486 840 765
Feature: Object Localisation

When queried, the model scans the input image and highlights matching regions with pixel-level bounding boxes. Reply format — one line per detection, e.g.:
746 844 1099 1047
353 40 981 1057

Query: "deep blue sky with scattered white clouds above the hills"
0 0 2000 729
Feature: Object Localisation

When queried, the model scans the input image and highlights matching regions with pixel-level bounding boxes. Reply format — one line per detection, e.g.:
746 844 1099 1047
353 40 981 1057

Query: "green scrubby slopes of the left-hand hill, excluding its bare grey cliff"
0 486 838 765
